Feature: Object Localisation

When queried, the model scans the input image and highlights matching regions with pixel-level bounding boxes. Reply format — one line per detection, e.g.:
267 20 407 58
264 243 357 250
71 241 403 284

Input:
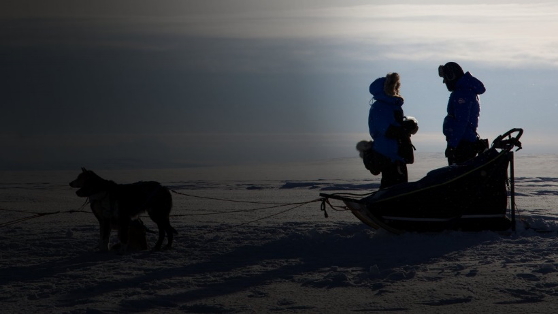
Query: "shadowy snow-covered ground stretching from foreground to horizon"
0 151 558 314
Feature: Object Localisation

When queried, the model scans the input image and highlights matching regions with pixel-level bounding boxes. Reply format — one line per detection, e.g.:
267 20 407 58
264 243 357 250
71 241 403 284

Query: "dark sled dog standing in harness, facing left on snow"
70 168 177 252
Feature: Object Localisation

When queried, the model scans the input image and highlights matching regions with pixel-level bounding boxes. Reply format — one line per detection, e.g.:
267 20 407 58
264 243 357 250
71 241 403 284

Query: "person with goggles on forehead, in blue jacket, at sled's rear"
438 62 486 165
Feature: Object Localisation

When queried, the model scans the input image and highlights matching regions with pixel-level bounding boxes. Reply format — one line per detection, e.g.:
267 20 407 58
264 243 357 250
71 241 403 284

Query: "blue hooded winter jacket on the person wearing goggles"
443 72 486 147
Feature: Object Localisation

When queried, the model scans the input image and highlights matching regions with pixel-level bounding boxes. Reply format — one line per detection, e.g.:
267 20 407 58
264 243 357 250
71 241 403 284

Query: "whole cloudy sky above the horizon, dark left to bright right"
0 0 558 169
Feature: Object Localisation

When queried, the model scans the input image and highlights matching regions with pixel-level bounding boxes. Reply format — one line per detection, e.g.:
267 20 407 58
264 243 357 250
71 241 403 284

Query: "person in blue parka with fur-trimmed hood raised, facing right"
368 73 418 189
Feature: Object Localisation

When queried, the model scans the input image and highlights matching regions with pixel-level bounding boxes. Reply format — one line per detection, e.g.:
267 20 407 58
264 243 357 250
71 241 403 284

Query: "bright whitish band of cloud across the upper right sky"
177 2 558 66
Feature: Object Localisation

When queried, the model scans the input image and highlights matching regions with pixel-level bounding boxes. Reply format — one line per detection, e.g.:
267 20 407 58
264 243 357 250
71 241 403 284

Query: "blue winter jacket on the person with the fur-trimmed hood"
368 77 403 161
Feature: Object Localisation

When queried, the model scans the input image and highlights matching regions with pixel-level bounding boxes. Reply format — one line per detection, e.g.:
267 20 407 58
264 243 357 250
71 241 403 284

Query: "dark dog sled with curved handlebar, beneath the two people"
320 128 523 233
